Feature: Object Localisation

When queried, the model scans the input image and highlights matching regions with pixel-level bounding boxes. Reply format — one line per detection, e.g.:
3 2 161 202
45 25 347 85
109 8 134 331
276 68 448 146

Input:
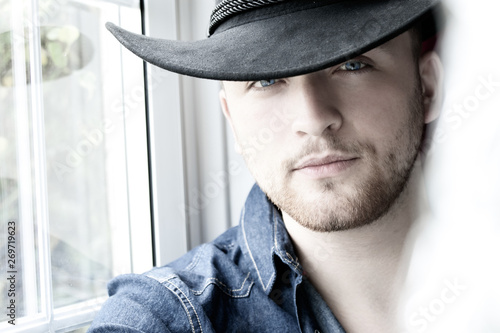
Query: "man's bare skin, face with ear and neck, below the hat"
220 32 441 332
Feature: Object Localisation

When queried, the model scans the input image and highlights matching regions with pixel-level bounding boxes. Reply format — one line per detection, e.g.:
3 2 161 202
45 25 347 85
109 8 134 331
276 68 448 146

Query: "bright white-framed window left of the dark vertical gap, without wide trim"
0 0 153 332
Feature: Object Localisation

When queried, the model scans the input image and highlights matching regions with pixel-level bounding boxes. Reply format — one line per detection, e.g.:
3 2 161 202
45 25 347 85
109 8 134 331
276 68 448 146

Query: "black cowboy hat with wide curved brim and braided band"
106 0 439 81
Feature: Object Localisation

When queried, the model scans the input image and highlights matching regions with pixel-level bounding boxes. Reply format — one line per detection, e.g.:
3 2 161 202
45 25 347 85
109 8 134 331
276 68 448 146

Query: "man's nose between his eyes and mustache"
291 76 343 136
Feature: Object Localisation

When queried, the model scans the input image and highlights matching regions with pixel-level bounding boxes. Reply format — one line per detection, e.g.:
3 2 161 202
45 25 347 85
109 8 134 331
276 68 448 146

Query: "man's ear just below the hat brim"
419 51 444 124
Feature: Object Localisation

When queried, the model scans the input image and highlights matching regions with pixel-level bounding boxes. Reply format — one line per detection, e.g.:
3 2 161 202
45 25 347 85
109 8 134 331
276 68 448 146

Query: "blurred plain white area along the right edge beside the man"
404 0 500 333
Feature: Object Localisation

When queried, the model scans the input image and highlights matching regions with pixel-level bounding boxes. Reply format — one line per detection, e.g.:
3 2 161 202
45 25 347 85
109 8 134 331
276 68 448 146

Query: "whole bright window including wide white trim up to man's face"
0 0 253 332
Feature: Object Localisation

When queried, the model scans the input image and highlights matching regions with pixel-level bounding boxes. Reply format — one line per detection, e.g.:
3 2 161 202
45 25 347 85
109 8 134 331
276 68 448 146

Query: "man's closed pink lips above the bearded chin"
292 155 359 178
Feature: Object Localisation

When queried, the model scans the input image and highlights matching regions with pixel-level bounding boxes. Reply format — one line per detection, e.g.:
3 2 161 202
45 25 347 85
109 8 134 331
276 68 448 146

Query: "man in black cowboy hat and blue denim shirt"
90 0 441 332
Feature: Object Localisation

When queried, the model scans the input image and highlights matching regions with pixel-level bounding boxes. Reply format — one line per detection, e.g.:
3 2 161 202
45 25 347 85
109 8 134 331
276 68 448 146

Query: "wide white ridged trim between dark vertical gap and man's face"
144 0 254 266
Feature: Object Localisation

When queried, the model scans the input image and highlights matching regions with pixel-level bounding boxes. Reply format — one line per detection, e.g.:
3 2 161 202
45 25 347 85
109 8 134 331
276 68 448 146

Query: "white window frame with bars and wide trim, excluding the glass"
0 0 253 332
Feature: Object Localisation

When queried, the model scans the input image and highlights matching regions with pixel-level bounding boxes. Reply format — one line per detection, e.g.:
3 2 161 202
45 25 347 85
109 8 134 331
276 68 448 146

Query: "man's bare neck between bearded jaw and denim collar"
283 163 421 333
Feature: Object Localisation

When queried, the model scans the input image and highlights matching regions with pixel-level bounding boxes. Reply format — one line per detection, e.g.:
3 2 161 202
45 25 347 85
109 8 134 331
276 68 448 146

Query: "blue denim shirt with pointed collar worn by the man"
88 186 344 333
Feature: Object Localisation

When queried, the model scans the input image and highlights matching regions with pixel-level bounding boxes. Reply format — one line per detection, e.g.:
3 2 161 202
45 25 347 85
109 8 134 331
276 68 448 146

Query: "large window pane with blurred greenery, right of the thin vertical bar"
40 4 115 307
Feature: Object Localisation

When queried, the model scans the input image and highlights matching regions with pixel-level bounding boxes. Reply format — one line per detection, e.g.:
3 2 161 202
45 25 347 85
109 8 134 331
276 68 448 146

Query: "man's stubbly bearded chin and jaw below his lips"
268 170 404 232
